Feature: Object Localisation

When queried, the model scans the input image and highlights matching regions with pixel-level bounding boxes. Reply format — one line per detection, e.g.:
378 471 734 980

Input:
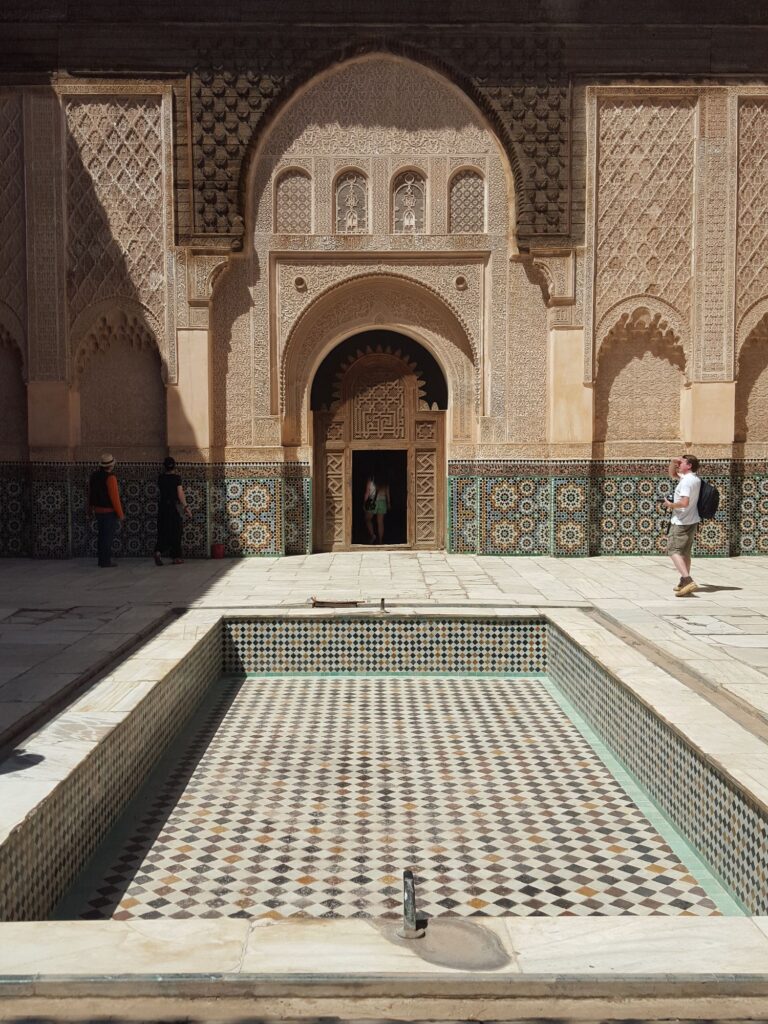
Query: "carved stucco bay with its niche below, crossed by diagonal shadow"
62 84 176 447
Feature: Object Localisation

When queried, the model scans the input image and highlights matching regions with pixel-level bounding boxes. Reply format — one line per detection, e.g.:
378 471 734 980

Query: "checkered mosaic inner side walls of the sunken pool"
0 613 768 921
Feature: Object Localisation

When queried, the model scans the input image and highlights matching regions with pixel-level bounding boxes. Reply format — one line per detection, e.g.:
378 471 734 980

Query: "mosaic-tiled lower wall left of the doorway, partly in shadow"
0 463 311 558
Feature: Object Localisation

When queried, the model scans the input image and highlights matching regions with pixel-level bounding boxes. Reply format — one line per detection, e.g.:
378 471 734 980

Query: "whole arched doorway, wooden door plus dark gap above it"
310 330 447 551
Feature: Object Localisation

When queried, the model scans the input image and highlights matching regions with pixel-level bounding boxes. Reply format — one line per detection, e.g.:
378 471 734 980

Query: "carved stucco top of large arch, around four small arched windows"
243 53 516 241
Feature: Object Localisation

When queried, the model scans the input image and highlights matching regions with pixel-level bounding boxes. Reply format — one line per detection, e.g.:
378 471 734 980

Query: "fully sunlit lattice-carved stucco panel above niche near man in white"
585 88 696 380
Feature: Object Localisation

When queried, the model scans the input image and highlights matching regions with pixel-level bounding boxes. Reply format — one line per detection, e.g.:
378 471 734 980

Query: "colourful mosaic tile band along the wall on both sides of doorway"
0 461 768 558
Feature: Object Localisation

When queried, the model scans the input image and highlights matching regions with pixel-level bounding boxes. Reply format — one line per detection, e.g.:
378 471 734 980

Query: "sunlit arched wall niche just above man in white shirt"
595 306 685 443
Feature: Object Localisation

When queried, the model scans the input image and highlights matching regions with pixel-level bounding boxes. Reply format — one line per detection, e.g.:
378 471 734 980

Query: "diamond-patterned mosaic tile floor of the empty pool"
55 676 740 921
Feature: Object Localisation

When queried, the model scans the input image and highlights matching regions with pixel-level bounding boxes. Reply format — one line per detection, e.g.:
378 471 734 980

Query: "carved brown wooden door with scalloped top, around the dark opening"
314 351 444 551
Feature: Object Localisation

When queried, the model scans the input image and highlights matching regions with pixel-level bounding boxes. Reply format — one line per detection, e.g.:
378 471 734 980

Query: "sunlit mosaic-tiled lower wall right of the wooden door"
449 461 737 557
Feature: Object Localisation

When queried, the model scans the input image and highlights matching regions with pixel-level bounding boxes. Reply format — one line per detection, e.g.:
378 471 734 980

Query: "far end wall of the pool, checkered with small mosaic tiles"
222 615 547 674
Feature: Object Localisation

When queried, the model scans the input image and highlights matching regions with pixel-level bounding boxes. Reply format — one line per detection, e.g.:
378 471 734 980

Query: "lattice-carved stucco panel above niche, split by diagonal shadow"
61 84 176 380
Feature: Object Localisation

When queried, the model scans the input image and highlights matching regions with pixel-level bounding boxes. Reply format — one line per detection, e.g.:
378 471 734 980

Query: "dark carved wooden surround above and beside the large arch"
187 35 582 247
